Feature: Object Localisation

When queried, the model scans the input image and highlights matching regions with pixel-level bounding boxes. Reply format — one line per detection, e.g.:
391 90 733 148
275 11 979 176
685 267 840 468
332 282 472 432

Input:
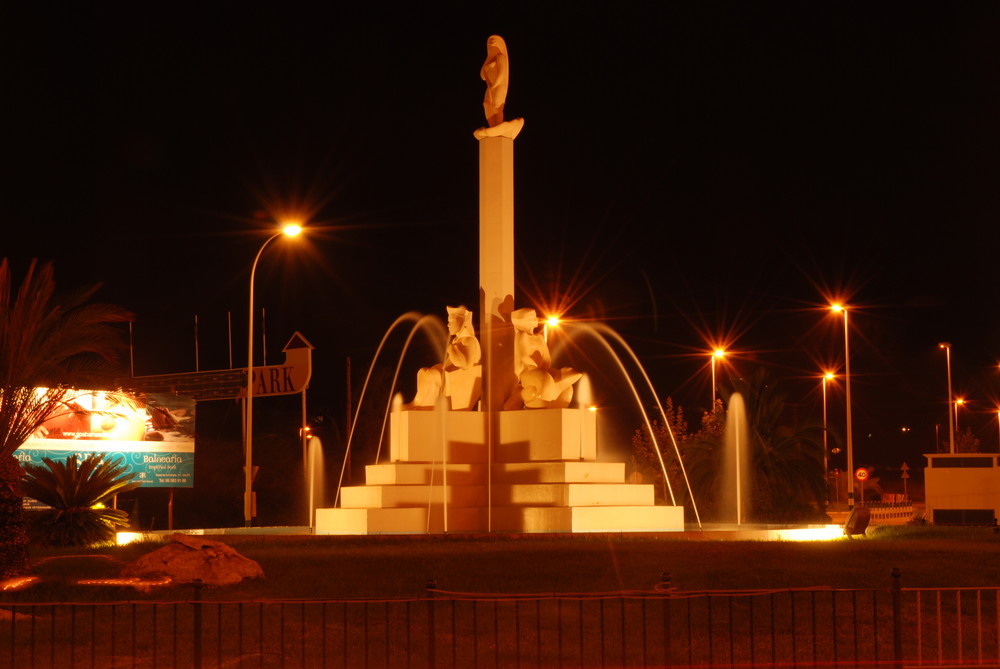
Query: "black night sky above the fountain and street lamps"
0 2 1000 465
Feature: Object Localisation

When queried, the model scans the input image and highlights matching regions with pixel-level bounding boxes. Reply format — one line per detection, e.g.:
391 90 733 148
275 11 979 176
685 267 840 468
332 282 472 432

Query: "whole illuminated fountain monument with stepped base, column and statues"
314 35 684 534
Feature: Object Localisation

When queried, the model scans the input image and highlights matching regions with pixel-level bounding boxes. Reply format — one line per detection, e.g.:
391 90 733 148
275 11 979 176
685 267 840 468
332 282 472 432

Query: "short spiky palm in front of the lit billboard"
22 453 140 546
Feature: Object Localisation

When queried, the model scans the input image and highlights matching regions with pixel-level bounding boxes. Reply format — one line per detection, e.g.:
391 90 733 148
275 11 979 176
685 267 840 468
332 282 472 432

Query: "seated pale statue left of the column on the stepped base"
411 307 483 411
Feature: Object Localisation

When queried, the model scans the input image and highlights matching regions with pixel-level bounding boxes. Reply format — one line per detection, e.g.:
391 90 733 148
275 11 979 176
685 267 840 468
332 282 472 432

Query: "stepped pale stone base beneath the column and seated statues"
314 409 684 534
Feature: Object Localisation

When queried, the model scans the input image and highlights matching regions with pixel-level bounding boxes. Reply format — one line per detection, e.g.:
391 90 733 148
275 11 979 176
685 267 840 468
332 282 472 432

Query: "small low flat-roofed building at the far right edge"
924 453 1000 525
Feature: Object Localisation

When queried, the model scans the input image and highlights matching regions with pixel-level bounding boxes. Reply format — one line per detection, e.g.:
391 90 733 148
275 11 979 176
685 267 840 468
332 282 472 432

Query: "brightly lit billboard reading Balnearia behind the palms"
14 390 195 488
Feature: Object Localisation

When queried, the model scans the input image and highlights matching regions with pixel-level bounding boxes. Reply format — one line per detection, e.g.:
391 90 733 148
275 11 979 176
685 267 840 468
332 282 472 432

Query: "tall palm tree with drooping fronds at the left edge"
0 259 131 579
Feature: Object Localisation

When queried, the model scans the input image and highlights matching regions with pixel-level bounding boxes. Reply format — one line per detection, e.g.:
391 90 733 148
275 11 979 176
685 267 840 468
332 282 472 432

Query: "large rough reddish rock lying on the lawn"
122 534 264 585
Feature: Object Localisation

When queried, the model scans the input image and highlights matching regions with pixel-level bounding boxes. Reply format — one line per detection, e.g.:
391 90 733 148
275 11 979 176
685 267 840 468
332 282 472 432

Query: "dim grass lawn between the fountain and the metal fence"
19 526 1000 601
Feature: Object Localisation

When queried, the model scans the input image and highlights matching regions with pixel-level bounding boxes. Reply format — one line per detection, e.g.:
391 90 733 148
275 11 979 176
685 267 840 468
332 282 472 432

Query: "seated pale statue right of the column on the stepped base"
504 309 583 410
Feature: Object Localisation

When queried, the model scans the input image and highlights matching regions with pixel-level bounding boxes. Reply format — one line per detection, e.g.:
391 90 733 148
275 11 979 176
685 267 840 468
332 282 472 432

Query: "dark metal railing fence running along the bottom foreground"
0 572 1000 669
